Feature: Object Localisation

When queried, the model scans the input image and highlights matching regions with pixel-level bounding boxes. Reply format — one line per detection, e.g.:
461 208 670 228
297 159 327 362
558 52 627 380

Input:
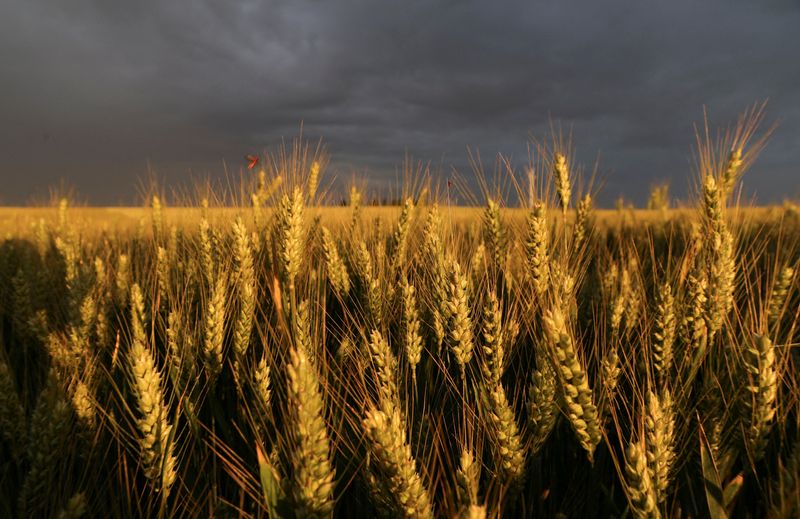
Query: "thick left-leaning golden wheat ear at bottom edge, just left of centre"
363 405 433 518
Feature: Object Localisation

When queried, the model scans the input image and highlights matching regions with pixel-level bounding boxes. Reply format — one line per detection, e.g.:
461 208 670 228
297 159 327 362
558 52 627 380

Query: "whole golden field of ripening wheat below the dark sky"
0 135 800 519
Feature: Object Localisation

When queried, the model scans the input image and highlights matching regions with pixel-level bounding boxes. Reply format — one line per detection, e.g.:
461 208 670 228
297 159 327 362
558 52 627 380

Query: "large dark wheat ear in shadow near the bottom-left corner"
19 371 72 517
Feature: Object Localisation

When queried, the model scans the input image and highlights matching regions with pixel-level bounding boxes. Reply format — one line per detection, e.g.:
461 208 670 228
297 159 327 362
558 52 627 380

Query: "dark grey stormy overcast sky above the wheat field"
0 0 800 204
